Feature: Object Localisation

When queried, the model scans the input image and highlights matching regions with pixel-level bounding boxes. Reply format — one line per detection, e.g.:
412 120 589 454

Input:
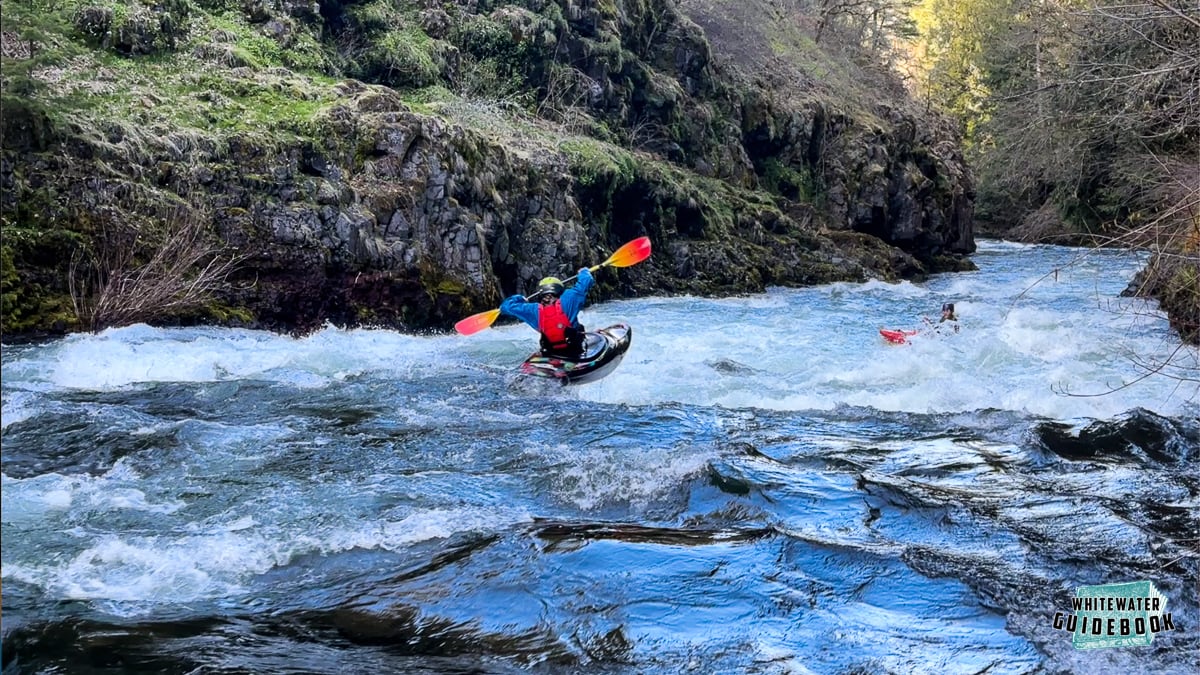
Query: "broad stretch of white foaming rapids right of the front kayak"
578 245 1198 418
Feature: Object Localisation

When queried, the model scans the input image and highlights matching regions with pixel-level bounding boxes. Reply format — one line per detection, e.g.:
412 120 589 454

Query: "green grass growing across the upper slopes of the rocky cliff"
0 0 816 234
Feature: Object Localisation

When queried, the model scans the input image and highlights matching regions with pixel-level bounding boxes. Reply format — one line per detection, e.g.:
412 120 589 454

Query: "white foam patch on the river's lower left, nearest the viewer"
2 458 530 607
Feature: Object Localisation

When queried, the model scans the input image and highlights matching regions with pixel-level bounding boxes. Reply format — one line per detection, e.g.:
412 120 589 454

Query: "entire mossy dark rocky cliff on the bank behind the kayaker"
0 0 974 334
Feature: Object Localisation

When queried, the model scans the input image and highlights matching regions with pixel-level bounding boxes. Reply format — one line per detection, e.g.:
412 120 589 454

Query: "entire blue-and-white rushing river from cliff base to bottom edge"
2 241 1200 674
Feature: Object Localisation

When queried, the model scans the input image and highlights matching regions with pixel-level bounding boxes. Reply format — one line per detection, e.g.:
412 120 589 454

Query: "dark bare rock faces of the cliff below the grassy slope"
0 0 974 331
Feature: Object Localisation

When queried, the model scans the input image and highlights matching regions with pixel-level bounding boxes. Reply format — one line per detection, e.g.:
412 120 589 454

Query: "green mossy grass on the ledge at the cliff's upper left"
0 4 348 135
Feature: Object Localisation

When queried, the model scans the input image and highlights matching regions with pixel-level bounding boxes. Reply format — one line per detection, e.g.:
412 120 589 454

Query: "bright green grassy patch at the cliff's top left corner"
0 0 340 138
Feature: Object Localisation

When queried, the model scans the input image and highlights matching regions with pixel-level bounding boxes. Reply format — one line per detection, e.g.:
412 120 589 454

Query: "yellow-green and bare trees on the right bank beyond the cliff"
911 0 1200 374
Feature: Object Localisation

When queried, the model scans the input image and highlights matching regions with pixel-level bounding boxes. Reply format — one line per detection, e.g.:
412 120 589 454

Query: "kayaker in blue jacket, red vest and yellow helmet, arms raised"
500 268 595 359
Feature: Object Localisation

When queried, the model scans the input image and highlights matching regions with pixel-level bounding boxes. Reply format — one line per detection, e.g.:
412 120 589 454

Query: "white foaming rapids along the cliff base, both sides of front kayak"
4 243 1200 425
